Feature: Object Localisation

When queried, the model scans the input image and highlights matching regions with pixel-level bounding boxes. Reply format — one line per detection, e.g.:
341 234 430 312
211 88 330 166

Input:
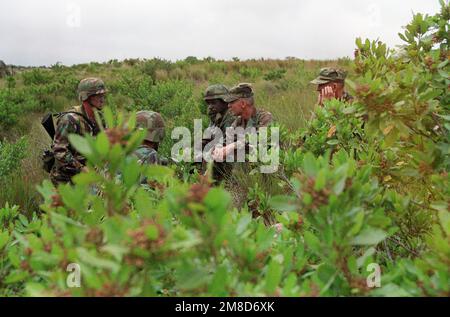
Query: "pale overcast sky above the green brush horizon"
0 0 439 65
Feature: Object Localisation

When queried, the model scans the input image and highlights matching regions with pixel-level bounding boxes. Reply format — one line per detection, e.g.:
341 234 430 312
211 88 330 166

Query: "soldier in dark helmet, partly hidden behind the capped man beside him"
202 84 235 182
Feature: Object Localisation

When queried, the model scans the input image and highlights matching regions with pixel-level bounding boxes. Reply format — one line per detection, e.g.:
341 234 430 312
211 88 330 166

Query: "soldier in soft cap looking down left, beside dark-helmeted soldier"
212 83 272 160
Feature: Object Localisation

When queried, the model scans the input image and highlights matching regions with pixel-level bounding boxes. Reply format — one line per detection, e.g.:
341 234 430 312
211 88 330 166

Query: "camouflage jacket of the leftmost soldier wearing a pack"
50 106 100 184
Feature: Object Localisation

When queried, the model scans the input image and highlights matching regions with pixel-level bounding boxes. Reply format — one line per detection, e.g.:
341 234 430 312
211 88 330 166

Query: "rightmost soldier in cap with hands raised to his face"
311 67 353 106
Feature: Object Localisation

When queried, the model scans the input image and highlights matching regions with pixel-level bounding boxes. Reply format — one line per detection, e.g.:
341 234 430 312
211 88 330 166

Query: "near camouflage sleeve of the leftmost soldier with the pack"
52 114 84 174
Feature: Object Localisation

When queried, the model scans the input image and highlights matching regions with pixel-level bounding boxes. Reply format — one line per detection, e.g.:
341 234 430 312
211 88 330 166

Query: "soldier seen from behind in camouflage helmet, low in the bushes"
134 111 165 164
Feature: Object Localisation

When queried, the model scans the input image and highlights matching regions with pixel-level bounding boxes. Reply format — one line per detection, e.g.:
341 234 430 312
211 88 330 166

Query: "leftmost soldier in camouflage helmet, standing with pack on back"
50 78 106 186
